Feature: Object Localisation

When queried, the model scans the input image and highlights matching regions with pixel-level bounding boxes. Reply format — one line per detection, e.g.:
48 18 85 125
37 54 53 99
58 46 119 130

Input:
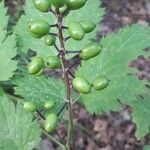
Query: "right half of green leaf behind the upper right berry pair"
65 0 104 53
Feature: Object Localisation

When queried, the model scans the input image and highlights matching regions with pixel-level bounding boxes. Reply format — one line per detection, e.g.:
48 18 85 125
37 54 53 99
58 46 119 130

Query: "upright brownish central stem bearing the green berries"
56 10 75 150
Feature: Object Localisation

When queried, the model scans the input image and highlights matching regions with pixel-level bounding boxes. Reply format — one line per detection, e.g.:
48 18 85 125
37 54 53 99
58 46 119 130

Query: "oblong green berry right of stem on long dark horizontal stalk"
80 42 102 60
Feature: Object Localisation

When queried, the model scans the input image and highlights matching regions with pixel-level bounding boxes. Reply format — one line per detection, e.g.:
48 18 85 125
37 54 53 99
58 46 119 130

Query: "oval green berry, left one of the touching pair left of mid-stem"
28 56 44 75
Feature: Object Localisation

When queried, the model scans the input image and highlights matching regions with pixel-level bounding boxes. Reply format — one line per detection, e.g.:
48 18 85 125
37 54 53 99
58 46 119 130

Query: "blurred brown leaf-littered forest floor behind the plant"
7 0 150 150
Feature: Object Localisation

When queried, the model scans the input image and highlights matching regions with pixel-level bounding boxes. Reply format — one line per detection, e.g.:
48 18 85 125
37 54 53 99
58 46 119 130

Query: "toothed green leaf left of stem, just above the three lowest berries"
13 75 66 112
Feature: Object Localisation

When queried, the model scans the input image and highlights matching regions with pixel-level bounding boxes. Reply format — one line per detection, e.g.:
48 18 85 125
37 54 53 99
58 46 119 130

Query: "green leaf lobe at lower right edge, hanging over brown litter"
132 96 150 139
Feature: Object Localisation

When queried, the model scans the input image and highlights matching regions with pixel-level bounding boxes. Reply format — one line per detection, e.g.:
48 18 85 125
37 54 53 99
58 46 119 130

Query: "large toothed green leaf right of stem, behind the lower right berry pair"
77 25 150 113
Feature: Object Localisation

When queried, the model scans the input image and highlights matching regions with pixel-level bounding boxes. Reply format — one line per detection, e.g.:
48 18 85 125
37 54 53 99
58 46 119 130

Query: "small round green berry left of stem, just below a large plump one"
43 35 56 46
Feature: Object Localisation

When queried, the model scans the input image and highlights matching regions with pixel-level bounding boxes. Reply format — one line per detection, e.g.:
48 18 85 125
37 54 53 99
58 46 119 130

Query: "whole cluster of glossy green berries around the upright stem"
24 0 109 132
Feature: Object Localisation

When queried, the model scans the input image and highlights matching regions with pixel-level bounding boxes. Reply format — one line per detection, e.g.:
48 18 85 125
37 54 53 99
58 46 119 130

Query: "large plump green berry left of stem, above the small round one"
28 20 50 37
